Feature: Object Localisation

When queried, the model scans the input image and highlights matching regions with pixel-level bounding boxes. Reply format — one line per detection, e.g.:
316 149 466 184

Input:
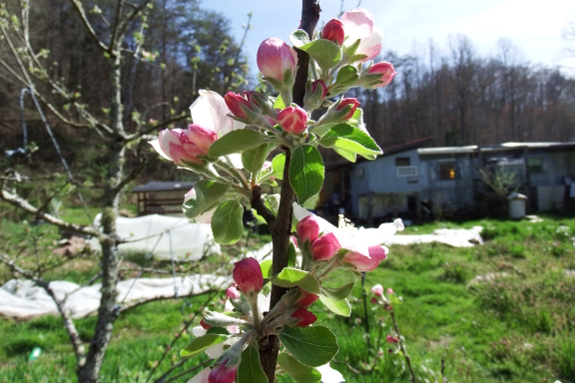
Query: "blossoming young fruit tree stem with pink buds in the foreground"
151 0 403 383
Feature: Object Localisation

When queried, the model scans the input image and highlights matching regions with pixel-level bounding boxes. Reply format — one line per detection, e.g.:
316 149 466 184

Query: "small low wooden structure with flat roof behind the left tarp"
132 181 194 215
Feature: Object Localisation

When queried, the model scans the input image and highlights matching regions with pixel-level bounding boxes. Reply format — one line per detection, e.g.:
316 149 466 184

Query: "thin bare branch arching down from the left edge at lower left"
0 254 86 367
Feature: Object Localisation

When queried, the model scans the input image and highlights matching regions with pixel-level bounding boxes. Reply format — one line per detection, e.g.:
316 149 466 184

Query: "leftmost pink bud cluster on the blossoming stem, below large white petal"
154 124 218 166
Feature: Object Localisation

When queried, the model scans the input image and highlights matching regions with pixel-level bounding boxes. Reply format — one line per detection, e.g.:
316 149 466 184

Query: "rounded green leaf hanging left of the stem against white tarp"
212 200 244 244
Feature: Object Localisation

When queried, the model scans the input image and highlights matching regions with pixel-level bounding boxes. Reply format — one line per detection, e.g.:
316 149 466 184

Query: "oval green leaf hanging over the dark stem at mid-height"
289 145 325 204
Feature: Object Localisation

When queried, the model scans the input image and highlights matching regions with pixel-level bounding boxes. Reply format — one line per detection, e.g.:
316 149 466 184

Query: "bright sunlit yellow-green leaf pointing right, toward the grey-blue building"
319 124 382 162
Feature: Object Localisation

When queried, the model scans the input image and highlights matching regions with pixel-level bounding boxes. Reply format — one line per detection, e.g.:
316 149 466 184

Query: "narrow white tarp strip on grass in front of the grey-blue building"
385 226 483 247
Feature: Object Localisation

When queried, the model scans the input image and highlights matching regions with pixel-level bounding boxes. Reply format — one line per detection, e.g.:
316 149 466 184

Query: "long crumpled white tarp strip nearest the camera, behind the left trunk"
0 274 230 319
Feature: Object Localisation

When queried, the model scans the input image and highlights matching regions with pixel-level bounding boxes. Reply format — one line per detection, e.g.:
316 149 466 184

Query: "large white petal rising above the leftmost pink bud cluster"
190 89 245 137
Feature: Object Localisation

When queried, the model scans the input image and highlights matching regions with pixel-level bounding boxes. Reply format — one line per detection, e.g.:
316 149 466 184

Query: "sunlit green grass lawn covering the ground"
0 217 575 383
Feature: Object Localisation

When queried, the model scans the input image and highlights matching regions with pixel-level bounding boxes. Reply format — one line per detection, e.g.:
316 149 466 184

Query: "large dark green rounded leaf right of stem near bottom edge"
278 326 339 367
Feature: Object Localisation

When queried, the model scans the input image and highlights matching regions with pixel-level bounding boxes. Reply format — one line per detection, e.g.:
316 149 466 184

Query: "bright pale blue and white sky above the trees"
202 0 575 76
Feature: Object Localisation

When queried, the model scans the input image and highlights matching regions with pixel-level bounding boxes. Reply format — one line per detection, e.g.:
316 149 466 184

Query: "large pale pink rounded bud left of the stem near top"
257 37 297 83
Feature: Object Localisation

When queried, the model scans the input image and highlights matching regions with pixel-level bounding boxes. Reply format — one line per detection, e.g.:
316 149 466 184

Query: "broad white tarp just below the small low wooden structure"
90 214 220 261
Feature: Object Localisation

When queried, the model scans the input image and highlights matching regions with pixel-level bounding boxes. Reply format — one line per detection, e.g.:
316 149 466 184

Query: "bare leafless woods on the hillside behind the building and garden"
0 0 575 181
